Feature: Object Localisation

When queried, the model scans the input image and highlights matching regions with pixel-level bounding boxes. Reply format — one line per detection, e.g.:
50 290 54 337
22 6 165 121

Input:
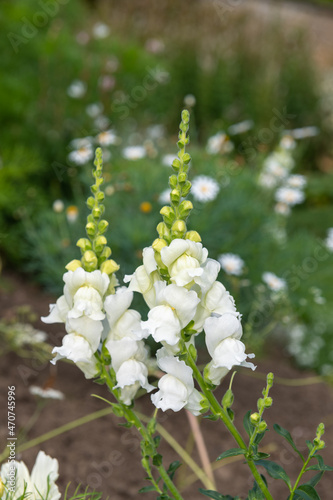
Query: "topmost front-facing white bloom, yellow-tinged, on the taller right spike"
161 239 208 286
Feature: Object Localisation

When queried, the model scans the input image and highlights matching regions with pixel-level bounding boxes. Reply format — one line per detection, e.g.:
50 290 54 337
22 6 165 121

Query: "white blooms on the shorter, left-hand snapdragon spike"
42 267 153 405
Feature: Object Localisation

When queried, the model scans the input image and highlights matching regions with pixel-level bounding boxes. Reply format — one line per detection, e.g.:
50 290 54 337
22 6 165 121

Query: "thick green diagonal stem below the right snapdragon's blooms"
187 352 273 500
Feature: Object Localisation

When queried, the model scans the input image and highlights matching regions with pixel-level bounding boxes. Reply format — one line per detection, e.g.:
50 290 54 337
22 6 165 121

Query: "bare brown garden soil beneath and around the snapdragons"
0 274 333 500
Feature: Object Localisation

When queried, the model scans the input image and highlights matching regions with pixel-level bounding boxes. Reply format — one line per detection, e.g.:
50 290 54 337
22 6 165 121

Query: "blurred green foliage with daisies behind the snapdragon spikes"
0 0 333 375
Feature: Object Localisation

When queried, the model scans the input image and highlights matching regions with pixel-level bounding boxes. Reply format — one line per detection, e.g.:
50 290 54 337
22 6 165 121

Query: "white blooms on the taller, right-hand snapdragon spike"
125 239 254 415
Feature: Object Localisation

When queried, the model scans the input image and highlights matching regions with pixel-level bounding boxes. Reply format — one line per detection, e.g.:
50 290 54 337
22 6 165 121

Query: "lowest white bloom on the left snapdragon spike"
105 337 155 405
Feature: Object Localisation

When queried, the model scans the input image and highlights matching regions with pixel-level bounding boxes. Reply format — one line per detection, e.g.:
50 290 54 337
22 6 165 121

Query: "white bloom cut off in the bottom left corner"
0 451 61 500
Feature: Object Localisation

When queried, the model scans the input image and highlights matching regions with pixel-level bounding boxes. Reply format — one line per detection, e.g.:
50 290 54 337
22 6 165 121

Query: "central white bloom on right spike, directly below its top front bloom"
141 282 200 346
